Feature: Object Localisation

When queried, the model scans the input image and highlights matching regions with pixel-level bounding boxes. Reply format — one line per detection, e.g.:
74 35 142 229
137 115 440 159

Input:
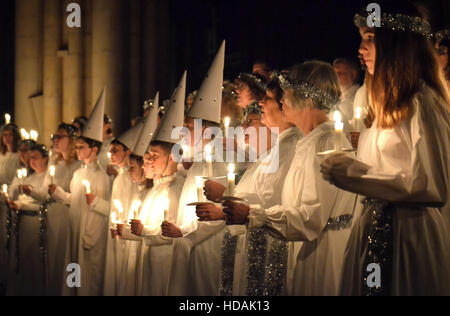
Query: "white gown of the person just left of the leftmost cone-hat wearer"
31 160 81 296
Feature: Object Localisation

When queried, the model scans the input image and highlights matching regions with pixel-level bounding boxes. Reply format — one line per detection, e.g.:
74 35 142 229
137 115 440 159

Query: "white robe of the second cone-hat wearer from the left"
104 168 136 296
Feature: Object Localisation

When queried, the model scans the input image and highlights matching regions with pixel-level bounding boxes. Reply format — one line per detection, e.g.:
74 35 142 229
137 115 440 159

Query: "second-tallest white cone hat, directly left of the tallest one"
152 71 187 143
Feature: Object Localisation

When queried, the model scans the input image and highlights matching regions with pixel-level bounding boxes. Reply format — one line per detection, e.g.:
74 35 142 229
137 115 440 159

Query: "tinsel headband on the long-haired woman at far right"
353 13 433 38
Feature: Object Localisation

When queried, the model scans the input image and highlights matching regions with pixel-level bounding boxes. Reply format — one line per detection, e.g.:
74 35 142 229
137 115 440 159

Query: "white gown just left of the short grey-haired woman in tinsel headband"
229 127 302 296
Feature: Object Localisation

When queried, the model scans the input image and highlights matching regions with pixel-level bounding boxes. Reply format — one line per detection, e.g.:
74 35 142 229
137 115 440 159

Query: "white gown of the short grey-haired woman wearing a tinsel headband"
249 121 355 296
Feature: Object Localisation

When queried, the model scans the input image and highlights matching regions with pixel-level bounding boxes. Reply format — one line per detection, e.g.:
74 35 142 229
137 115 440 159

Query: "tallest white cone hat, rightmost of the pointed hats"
188 41 225 124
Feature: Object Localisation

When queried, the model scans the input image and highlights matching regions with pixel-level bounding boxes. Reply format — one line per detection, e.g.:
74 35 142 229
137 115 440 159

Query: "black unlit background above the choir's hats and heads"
0 0 450 113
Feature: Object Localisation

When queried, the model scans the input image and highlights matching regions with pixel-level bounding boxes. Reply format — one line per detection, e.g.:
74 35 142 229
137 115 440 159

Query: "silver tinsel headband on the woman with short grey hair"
272 73 340 110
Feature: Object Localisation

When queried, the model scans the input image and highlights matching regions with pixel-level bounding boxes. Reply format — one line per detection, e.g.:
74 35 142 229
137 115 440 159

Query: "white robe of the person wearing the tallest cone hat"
167 157 227 296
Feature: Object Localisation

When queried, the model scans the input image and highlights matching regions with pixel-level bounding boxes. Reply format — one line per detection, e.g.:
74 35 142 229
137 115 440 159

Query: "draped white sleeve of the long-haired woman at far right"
329 94 450 207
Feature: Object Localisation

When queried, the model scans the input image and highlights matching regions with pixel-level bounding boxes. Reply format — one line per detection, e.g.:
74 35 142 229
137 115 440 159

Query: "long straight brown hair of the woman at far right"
367 1 450 129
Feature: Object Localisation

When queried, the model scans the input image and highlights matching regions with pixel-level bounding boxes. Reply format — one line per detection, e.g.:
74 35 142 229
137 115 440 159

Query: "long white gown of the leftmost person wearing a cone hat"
53 160 111 296
